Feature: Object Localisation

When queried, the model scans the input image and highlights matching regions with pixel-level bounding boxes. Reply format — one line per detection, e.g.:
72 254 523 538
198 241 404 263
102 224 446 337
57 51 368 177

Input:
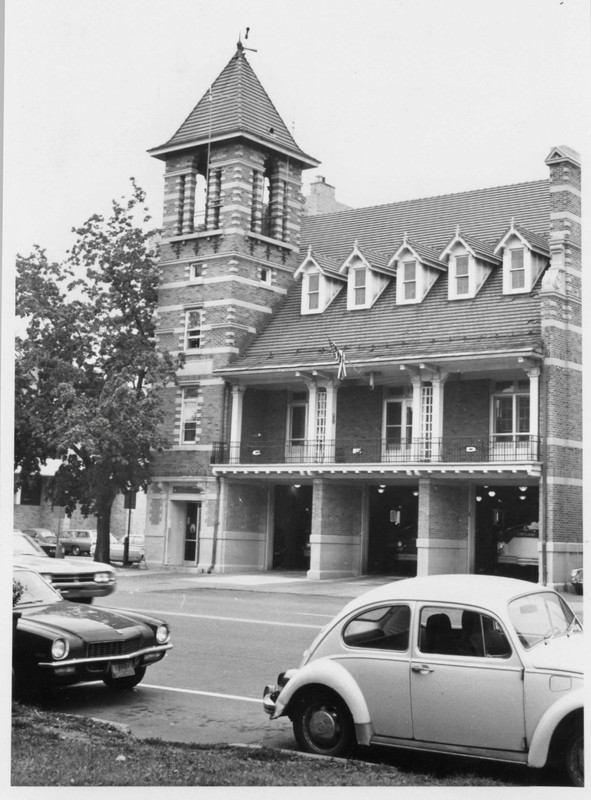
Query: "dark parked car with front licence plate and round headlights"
12 568 172 696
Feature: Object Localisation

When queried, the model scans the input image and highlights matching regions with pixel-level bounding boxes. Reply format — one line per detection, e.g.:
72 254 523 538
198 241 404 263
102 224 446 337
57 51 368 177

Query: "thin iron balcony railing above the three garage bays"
212 434 540 465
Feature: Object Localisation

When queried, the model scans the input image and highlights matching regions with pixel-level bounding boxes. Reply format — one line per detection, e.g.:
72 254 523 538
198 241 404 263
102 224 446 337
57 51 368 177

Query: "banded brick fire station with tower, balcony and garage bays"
146 43 582 586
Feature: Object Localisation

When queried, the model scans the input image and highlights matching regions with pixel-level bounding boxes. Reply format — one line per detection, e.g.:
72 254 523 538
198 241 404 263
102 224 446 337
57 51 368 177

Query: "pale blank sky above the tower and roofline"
4 0 589 269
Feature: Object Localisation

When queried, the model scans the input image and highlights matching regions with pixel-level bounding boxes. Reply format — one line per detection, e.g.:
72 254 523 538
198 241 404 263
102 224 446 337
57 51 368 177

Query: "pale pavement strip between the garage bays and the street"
117 566 583 619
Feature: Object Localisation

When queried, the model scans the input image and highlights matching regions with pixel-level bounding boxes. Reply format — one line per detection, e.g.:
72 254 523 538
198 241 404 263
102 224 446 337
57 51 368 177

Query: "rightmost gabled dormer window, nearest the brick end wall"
495 222 550 294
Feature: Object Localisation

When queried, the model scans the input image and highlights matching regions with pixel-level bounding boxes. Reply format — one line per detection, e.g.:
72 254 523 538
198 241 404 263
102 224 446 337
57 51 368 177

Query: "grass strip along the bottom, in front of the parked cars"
11 703 540 786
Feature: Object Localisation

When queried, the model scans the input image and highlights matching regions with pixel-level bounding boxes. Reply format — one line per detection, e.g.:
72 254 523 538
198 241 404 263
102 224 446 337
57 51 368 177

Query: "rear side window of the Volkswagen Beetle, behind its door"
343 605 410 651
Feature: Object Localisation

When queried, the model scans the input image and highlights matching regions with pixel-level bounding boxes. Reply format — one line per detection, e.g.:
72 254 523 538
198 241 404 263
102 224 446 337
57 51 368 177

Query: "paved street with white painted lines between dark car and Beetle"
31 569 583 780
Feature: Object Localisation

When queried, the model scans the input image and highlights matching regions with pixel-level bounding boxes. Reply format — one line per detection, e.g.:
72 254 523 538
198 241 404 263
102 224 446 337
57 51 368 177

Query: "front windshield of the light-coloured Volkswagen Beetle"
509 592 582 650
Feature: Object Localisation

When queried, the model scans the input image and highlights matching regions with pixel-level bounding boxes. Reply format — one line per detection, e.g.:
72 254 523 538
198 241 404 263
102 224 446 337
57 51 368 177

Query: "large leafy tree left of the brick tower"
15 181 181 561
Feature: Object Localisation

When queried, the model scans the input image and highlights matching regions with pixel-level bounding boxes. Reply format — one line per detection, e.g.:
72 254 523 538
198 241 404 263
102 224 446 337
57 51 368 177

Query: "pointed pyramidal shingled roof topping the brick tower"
148 42 320 167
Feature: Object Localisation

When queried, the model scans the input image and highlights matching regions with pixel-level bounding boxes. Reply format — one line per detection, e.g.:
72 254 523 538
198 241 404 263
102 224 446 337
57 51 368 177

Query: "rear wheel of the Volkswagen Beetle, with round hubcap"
291 689 355 756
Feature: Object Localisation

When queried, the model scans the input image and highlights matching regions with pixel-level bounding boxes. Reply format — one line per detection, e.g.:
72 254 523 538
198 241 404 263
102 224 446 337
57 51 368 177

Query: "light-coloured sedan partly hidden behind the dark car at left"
12 532 117 603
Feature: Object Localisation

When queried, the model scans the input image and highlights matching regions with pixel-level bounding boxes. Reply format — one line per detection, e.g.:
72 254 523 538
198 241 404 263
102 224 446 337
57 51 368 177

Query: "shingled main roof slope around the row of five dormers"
223 180 549 373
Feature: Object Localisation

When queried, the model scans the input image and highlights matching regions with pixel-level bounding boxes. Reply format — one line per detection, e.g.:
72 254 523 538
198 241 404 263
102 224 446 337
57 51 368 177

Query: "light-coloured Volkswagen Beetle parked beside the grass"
263 575 584 786
